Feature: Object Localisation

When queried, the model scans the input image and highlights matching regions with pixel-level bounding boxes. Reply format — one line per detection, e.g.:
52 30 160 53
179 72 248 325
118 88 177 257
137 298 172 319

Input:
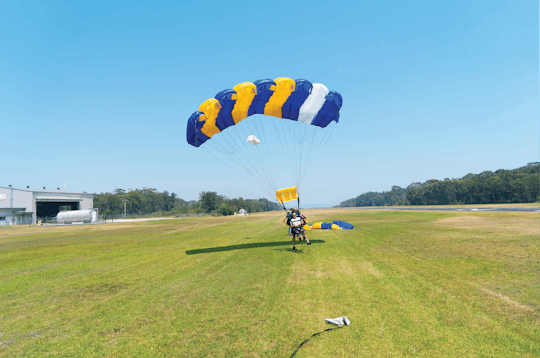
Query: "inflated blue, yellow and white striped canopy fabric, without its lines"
186 77 343 147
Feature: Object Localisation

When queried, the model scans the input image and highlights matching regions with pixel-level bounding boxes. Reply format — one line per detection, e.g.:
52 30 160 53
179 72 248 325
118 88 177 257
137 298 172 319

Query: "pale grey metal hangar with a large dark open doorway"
0 185 94 225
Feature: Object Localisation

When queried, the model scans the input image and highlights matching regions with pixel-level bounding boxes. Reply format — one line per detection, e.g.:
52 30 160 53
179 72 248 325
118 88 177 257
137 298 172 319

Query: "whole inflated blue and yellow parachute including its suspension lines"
186 77 343 204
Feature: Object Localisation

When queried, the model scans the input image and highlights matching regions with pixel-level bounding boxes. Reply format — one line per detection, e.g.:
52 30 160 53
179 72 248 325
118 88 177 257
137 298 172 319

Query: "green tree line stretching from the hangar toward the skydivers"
94 188 281 218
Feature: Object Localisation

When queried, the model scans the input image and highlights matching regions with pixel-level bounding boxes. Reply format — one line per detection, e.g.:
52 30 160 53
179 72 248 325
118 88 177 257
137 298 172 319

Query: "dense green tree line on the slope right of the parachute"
338 162 540 207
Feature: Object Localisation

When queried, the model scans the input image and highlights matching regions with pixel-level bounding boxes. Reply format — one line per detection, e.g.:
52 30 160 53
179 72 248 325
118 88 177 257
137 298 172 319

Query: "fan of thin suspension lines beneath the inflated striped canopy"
196 114 335 206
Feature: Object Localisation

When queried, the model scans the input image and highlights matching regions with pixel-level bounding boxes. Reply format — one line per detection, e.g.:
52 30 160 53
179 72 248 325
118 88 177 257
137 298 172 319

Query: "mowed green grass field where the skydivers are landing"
0 209 540 357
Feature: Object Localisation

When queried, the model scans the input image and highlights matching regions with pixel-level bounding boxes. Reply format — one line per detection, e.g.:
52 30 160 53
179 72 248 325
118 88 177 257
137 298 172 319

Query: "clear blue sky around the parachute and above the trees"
0 0 539 204
